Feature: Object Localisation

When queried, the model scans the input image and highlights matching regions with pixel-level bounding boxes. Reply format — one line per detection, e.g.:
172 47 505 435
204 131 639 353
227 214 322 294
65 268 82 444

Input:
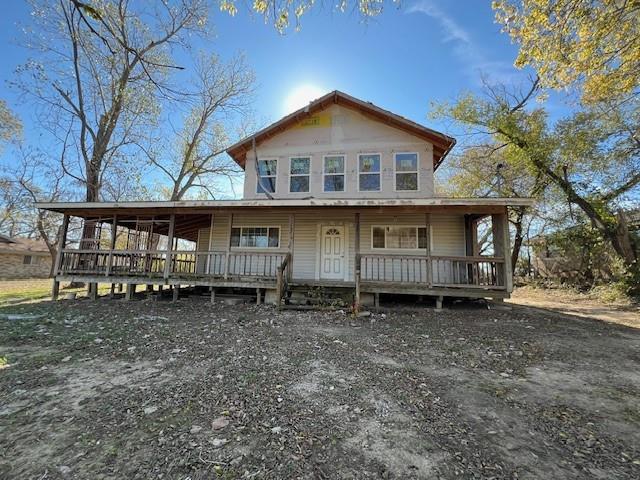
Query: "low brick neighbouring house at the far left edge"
0 234 51 279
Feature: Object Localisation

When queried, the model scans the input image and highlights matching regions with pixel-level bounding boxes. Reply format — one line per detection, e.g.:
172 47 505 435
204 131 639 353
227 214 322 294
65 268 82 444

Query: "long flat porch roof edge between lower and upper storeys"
36 197 533 218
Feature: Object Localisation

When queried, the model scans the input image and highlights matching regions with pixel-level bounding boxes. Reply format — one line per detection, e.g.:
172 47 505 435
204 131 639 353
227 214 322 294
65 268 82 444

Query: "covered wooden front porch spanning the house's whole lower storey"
41 199 528 306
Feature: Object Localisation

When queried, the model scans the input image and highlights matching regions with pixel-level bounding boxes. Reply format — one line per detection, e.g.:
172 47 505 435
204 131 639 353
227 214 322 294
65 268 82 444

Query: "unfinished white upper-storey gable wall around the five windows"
244 105 434 199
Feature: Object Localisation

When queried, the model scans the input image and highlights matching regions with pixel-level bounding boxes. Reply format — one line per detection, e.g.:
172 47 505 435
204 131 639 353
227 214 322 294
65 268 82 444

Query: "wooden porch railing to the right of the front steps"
360 254 505 289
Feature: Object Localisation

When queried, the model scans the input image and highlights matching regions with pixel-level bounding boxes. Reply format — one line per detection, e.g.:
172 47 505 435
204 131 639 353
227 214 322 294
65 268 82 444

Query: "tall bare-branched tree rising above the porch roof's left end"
17 0 208 202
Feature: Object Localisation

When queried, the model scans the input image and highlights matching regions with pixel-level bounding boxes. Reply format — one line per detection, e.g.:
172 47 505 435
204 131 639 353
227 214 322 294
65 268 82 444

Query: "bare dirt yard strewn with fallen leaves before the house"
0 297 640 479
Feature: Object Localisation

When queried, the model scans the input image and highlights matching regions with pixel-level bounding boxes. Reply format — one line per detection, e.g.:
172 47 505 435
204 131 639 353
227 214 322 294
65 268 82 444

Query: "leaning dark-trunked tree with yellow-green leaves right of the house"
435 80 640 293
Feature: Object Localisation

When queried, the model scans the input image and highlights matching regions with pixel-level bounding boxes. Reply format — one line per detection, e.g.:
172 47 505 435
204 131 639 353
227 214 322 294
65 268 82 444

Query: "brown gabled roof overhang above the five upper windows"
227 90 456 170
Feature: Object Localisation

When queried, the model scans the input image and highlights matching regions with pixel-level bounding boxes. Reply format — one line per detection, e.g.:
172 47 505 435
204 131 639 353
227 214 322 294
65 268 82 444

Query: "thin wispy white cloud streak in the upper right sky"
406 0 522 84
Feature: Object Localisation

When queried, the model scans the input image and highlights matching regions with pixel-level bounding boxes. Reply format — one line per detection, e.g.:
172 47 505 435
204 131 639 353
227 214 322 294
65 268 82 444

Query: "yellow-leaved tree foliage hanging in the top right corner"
493 0 640 103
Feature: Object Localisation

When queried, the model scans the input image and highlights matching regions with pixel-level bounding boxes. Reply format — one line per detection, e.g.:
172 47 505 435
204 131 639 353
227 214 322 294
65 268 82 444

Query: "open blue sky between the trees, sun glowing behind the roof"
0 0 544 193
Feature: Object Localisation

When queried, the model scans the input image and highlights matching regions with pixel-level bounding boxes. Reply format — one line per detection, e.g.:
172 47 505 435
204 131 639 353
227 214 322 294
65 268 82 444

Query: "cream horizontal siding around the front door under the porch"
197 209 465 281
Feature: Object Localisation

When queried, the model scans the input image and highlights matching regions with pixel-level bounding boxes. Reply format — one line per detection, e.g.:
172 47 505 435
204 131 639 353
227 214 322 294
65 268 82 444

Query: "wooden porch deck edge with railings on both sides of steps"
56 249 509 298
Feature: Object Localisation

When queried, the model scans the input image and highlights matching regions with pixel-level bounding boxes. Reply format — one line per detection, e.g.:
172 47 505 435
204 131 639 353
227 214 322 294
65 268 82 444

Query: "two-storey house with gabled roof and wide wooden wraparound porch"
39 91 531 305
